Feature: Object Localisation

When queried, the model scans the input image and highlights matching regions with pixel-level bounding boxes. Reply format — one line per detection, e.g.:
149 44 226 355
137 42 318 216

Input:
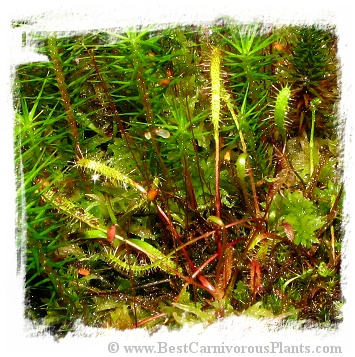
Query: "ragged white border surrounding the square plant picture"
0 0 355 357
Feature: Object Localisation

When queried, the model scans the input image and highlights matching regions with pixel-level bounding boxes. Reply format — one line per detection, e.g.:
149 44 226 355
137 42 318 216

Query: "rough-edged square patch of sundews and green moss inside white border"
14 19 343 336
